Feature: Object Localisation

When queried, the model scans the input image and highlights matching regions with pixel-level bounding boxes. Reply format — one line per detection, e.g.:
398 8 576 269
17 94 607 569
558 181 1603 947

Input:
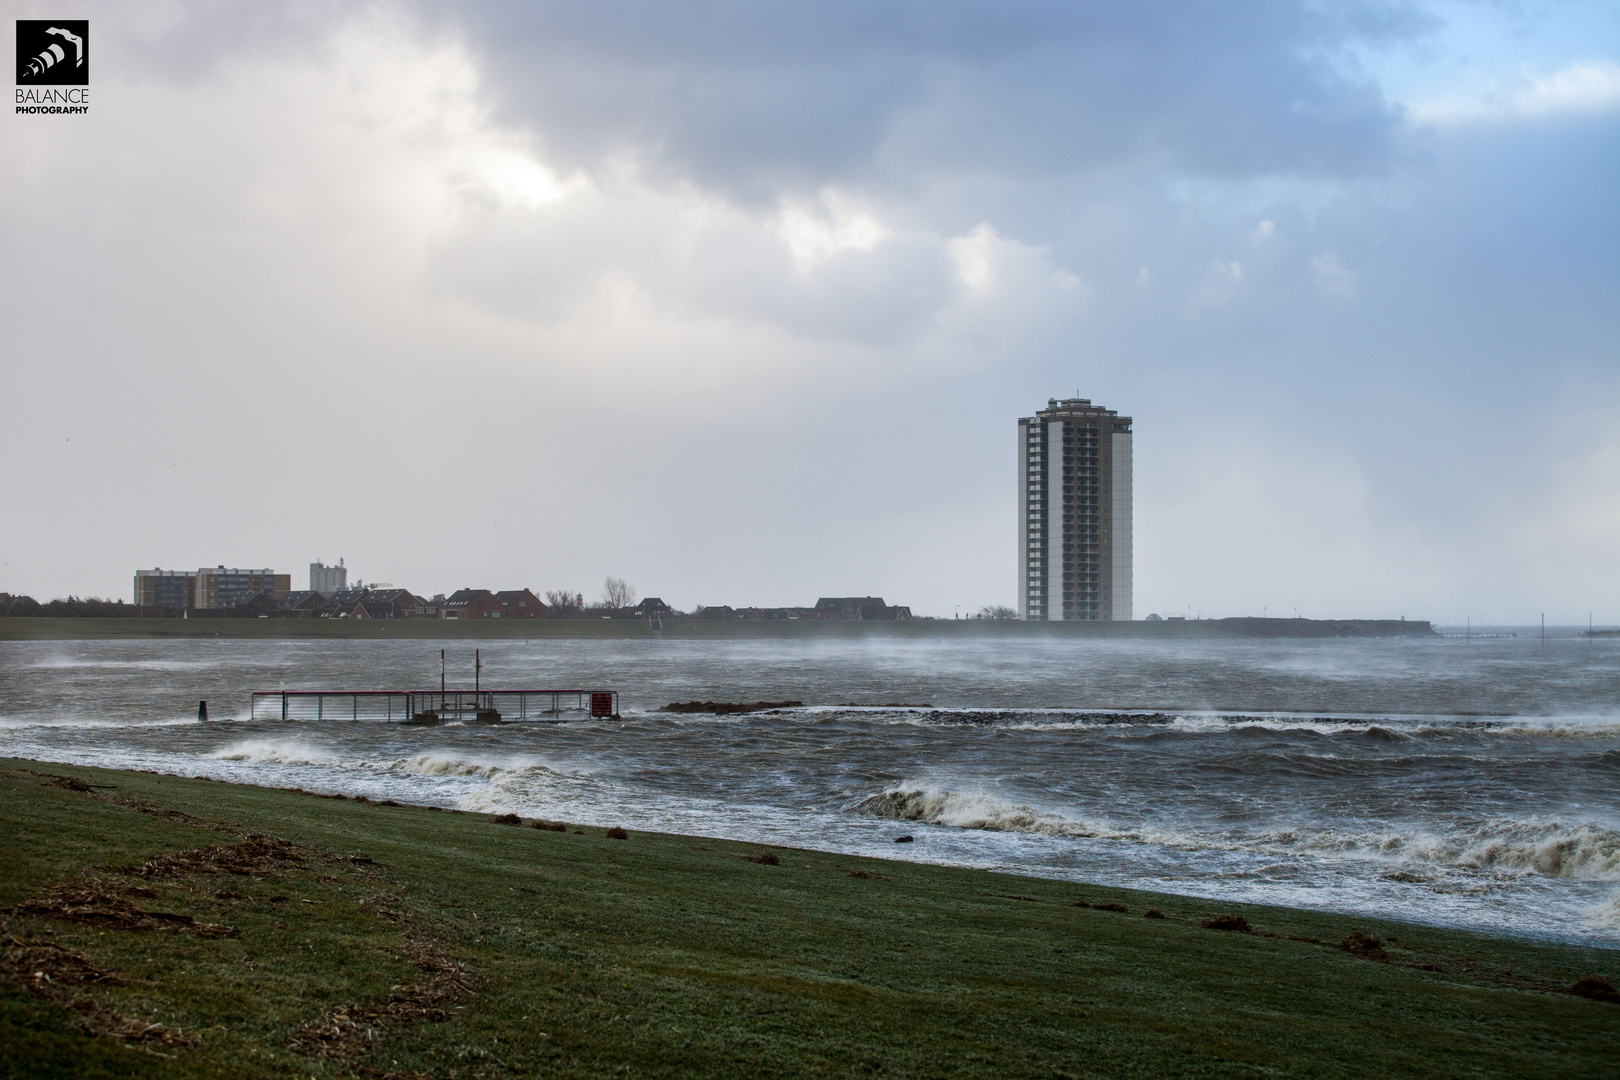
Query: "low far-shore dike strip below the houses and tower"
0 617 1440 641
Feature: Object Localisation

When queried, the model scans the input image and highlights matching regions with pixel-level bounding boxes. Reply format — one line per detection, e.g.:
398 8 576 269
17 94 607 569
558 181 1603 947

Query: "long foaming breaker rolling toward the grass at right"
854 789 1620 881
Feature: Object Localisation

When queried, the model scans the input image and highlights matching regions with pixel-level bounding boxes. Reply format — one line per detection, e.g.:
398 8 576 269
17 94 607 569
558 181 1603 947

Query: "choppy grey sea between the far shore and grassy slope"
0 638 1620 946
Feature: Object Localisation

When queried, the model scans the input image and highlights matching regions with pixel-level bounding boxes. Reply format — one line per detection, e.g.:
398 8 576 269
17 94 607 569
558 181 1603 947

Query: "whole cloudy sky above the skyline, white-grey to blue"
0 0 1620 623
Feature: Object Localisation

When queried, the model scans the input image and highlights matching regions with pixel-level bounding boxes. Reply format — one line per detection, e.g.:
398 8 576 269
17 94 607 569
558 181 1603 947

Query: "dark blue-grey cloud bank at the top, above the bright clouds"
424 0 1430 194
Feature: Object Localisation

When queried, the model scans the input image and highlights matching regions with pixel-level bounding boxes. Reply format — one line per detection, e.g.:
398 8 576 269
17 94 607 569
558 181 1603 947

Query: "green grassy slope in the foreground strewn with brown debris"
0 759 1620 1078
